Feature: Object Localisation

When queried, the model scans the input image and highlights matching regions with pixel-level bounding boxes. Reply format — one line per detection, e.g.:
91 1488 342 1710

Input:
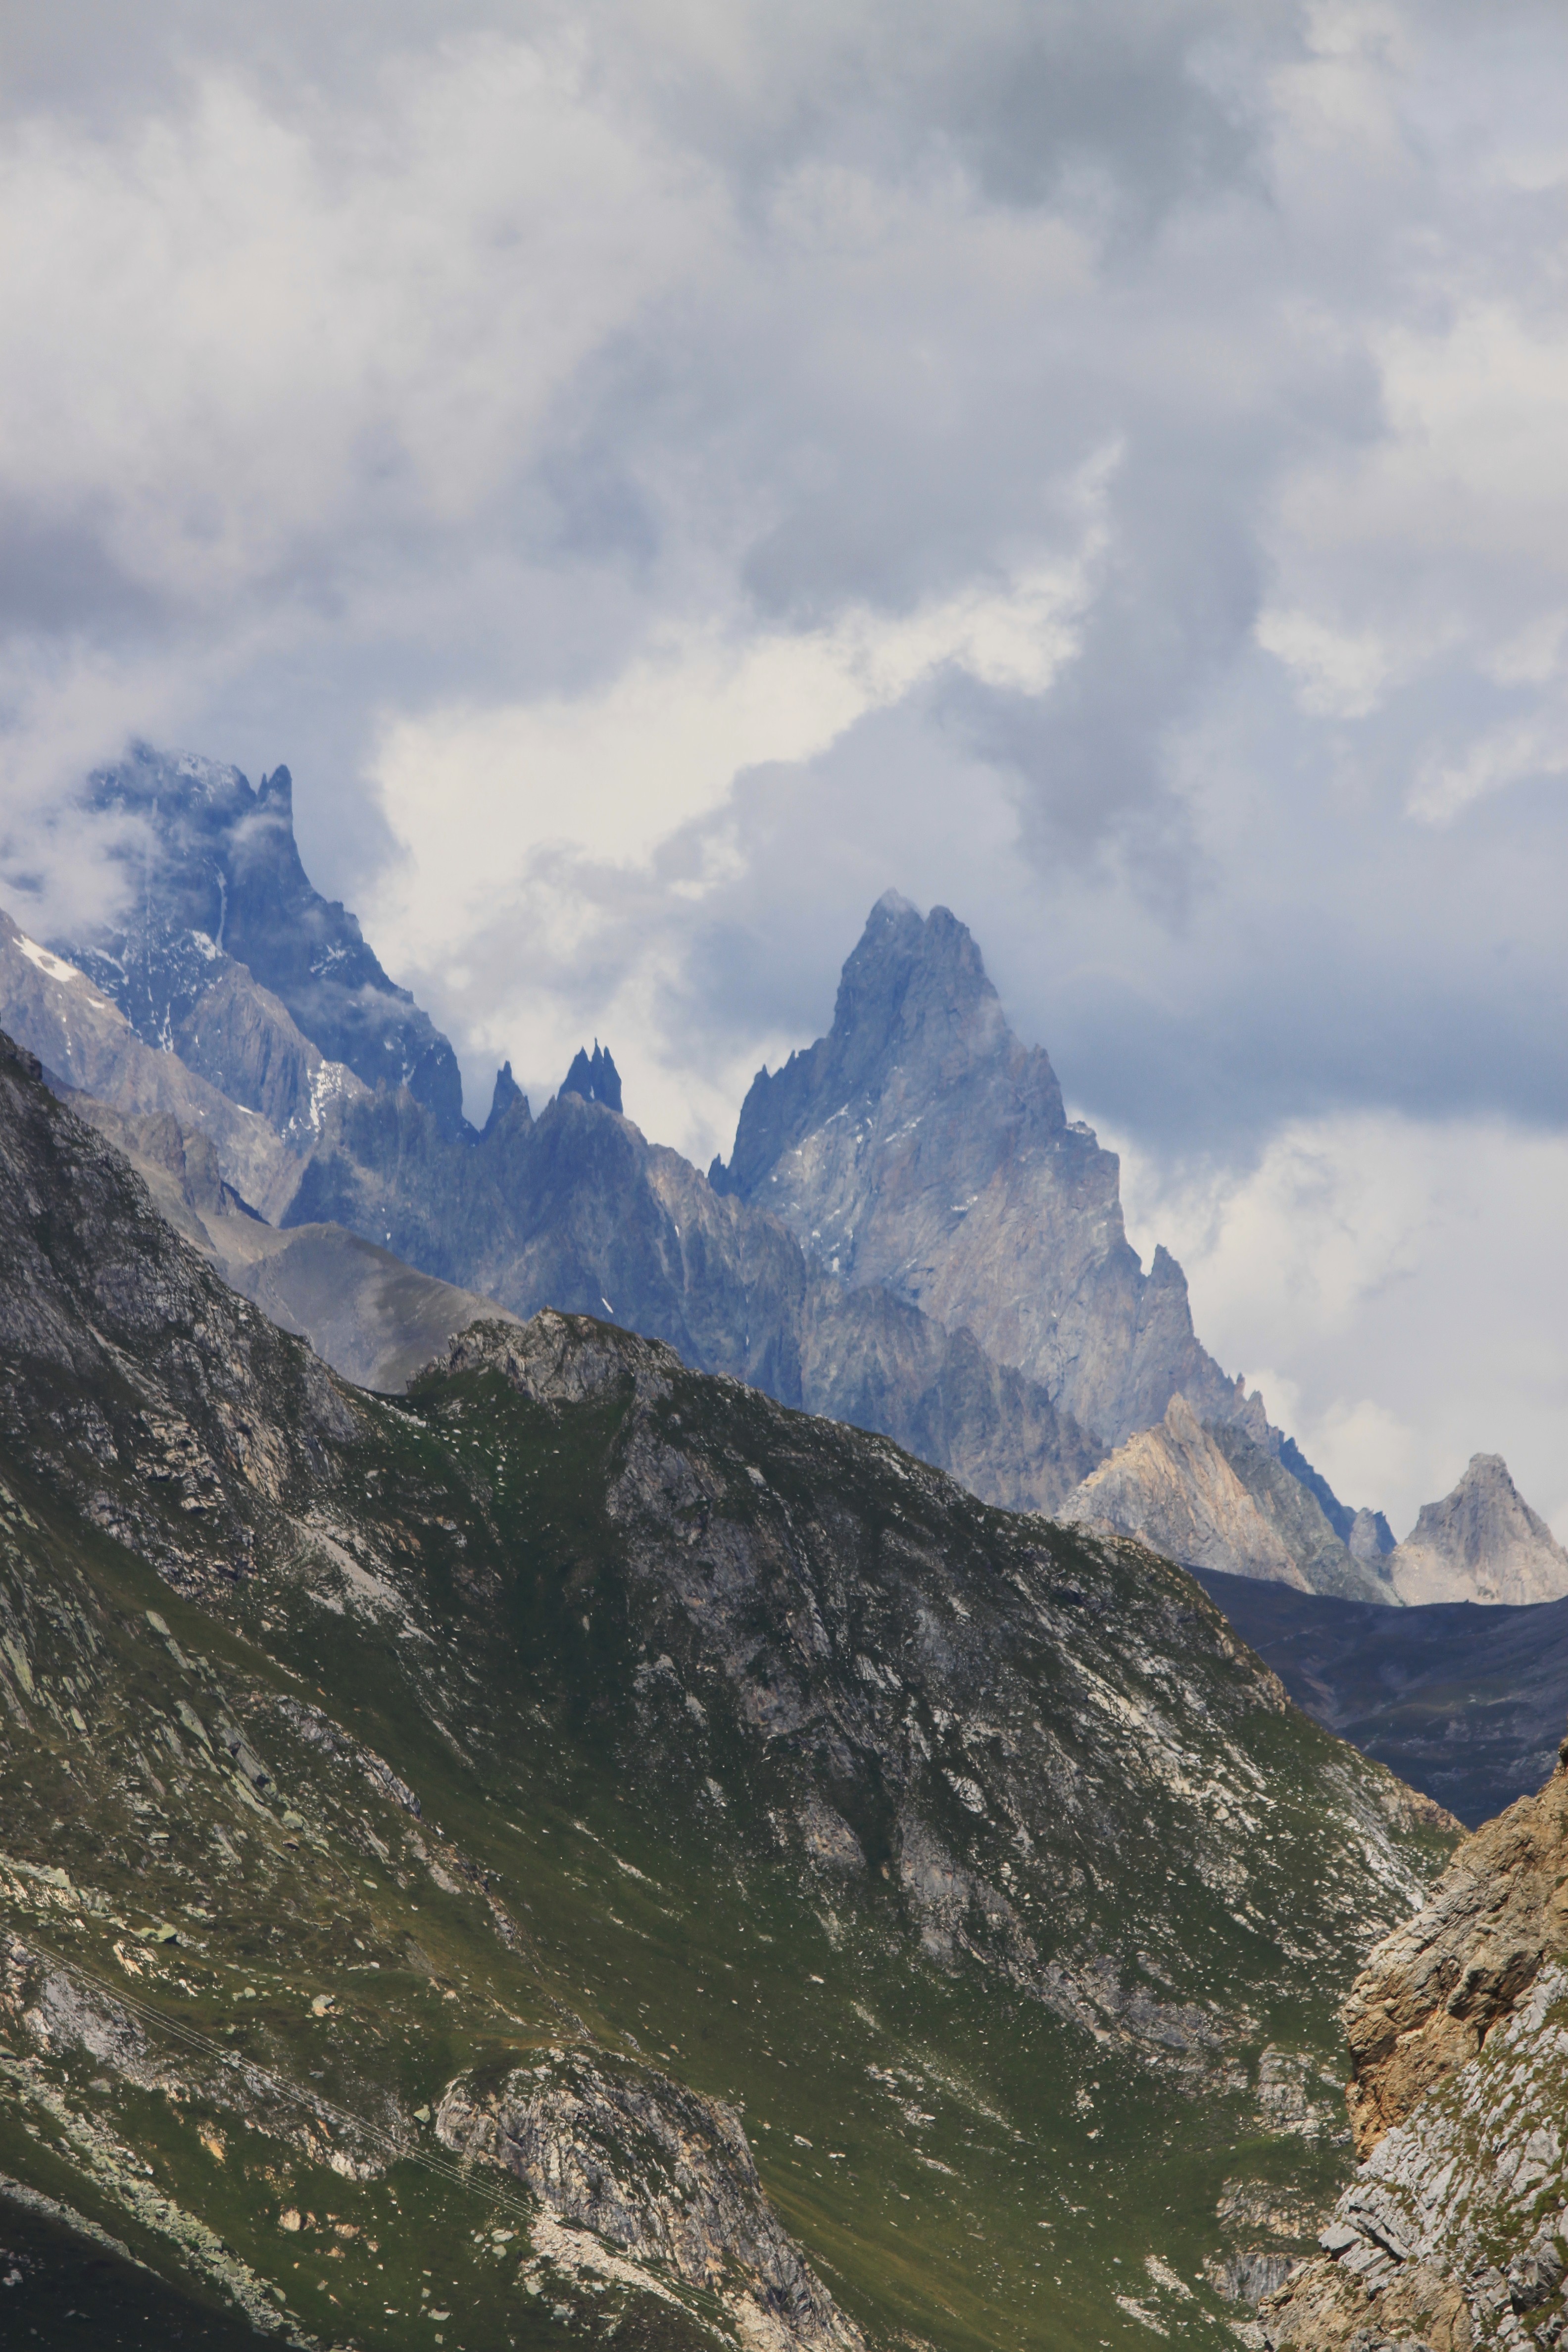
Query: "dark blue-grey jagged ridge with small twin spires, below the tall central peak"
287 1082 1100 1510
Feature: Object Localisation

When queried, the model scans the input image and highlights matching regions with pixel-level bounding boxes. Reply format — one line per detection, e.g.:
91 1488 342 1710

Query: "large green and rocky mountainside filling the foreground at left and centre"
0 1034 1451 2352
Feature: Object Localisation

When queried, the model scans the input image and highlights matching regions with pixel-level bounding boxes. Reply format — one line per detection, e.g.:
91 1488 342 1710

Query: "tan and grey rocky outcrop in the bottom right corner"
1260 1743 1568 2352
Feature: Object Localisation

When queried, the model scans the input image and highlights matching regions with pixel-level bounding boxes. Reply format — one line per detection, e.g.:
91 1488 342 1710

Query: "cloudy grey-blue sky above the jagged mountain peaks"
0 0 1568 1533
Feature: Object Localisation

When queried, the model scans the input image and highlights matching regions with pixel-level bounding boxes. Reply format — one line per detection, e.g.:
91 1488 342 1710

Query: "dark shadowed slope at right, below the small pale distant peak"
1197 1569 1568 1830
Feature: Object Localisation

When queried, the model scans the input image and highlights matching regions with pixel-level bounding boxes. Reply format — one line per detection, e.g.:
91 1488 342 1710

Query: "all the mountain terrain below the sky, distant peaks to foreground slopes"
0 753 1568 2352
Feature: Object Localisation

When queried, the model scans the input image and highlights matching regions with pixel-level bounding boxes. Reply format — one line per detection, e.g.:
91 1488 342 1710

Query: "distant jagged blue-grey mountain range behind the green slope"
12 748 1532 1602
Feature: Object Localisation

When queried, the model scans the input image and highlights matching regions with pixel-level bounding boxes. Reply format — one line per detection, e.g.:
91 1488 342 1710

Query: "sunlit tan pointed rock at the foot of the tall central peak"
1063 1395 1396 1604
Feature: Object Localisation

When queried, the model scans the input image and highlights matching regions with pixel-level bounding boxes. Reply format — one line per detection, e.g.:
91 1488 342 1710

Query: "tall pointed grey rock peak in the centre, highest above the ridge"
712 891 1244 1444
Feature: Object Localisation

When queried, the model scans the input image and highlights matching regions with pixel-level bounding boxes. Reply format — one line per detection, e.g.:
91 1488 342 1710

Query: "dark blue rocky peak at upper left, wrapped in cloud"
59 745 463 1133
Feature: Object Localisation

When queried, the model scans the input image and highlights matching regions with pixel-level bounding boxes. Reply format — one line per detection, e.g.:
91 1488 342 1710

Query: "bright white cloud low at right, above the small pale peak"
1122 1113 1568 1536
